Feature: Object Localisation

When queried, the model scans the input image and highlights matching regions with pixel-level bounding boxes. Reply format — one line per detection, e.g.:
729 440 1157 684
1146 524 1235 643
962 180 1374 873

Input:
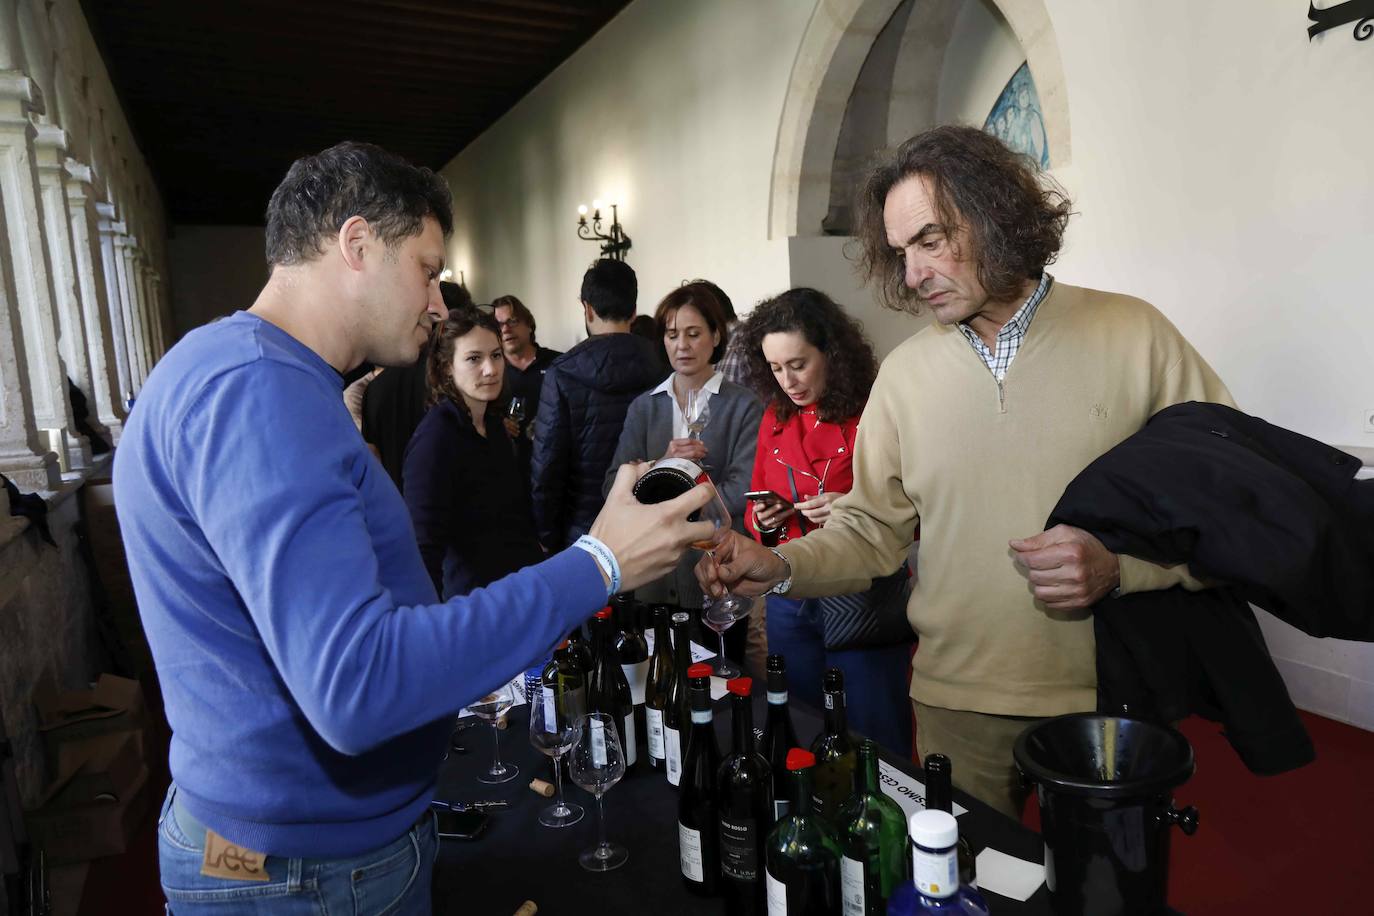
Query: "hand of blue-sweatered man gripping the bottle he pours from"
589 463 719 592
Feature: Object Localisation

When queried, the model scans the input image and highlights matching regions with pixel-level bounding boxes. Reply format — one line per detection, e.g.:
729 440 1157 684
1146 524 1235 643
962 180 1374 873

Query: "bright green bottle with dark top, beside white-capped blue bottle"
840 737 907 916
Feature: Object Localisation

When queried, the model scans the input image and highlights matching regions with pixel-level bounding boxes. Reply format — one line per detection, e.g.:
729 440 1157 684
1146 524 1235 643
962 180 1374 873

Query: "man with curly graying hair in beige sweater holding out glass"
698 126 1231 817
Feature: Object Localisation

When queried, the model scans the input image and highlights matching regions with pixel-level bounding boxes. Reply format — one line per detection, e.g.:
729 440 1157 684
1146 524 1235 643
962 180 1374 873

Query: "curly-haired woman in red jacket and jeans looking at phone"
739 288 911 757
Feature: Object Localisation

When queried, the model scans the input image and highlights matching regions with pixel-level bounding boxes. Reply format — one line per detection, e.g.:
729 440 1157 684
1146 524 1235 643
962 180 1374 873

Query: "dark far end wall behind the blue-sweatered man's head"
168 225 267 339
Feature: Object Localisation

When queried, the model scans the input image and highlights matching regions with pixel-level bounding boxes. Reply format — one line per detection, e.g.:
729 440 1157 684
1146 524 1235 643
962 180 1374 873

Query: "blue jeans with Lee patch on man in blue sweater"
158 783 438 916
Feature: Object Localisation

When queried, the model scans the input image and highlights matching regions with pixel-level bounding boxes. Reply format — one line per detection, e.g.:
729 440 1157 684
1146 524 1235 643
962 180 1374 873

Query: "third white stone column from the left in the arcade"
66 159 124 444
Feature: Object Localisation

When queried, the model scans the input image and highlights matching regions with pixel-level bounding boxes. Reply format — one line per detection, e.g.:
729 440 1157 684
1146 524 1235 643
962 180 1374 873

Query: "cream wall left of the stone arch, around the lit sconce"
444 0 811 349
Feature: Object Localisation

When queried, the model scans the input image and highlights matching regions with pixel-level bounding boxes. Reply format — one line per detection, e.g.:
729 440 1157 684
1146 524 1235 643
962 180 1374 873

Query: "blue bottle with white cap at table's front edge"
888 809 988 916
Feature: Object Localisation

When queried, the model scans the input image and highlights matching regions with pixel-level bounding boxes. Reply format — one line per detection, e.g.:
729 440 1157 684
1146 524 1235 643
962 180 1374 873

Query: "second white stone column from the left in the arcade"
34 124 95 468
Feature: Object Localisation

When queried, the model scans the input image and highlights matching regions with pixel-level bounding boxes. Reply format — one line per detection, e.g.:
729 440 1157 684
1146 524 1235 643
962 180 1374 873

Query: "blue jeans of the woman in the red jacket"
768 596 911 759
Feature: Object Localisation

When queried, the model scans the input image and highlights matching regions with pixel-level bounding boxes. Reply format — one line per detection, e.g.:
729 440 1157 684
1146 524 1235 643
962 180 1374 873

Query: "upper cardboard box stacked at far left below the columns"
33 674 148 777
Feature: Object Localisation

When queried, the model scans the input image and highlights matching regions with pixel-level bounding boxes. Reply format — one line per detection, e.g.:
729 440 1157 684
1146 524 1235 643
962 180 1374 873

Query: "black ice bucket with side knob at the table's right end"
1014 713 1198 916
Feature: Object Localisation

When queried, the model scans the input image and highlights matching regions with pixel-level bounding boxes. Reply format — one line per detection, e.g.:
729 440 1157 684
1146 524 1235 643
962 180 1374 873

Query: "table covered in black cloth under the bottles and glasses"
434 691 1050 916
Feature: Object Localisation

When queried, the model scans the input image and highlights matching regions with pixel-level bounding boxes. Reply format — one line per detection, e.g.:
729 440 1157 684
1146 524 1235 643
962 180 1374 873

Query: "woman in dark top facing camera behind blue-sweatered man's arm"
403 309 544 600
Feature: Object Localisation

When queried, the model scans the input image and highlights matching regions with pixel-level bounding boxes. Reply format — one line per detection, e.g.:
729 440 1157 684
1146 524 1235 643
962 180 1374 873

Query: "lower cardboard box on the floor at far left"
25 732 151 864
